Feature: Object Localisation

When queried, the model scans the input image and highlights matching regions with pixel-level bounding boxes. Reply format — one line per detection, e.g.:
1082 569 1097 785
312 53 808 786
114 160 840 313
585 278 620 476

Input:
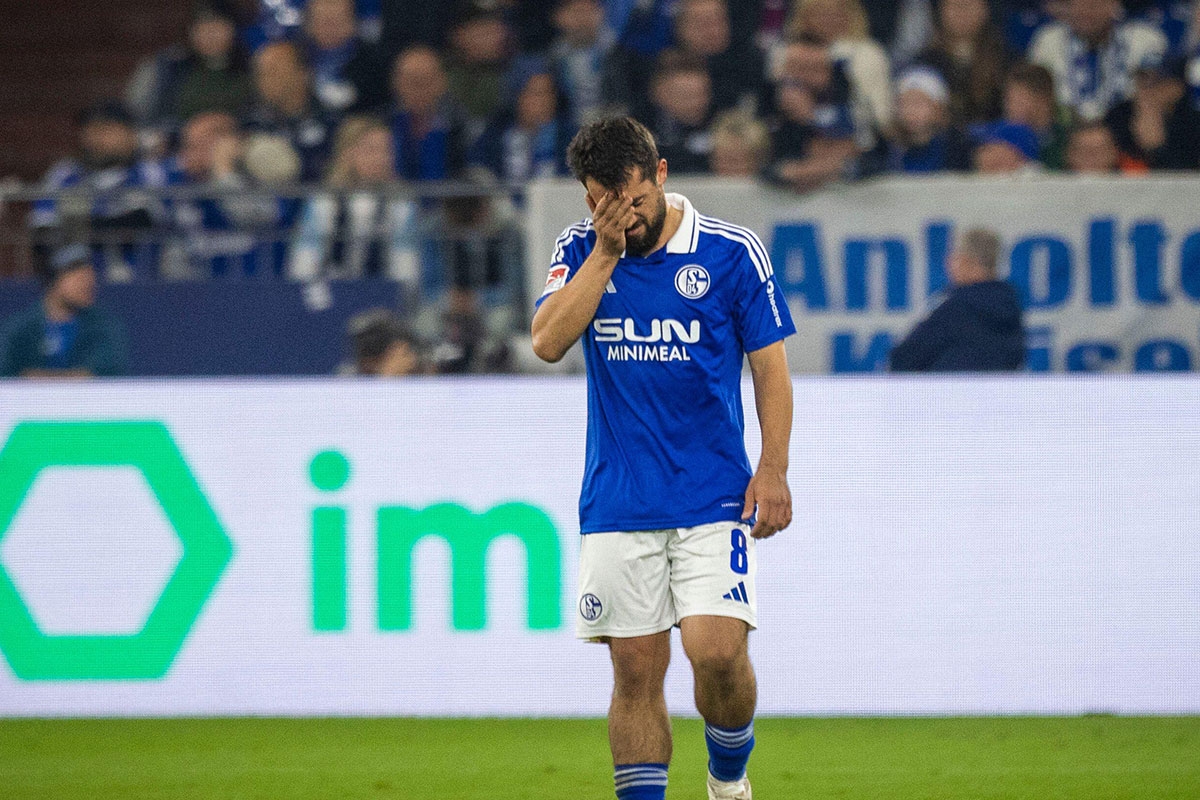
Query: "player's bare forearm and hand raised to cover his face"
532 192 635 363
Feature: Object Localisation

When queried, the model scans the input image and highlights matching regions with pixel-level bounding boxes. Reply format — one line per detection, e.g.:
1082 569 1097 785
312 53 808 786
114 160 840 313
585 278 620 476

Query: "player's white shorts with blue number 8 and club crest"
575 522 758 639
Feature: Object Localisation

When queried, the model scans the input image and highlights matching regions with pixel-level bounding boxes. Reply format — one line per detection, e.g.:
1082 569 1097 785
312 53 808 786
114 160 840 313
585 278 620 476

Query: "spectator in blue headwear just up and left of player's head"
470 64 575 181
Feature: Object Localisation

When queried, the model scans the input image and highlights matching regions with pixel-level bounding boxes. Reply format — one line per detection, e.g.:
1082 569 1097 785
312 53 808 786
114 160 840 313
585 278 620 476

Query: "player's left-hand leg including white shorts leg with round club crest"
576 531 677 800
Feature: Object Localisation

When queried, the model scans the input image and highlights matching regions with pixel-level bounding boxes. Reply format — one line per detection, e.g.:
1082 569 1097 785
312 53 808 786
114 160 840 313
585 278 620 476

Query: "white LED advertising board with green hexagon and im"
0 378 1200 716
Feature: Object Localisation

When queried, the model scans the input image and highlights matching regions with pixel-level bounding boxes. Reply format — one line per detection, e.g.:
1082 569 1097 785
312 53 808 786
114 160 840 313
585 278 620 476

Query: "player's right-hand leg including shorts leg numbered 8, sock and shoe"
668 523 757 800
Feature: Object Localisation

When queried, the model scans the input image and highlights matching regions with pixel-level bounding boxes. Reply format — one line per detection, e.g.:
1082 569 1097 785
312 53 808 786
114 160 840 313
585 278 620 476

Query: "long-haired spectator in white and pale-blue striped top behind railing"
288 116 420 284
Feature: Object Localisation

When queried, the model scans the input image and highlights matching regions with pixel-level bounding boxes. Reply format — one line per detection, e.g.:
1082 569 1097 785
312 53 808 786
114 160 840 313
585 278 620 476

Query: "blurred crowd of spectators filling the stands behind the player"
7 0 1200 376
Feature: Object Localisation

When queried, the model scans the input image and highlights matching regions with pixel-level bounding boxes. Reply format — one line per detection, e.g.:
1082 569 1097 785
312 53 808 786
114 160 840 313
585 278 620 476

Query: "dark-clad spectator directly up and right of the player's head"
640 50 713 175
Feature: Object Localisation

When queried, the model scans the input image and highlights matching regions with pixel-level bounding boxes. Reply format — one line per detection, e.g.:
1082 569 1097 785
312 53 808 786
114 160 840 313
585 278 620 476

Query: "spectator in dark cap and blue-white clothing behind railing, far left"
30 101 167 281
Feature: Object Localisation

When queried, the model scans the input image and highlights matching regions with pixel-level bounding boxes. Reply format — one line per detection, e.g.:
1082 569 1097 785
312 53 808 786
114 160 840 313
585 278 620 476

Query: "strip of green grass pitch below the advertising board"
0 716 1200 800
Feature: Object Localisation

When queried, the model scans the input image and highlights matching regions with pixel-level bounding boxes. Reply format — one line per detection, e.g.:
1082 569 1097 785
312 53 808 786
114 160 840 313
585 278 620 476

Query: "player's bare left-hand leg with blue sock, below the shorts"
608 631 671 800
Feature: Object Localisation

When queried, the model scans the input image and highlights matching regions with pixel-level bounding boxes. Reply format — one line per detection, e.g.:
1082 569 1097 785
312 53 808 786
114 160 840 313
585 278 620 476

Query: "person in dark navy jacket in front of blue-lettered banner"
889 228 1025 372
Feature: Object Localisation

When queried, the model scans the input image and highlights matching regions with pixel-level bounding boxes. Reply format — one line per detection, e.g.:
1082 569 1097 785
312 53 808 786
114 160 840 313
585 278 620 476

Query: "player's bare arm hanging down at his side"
742 341 792 539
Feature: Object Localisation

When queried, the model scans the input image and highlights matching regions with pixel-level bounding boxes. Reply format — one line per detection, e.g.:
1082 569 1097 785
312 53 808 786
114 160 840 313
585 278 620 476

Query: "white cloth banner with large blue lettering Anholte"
527 175 1200 373
